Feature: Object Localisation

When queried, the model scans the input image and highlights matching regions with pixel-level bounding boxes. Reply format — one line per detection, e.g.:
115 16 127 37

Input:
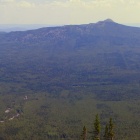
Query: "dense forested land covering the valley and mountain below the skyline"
0 20 140 140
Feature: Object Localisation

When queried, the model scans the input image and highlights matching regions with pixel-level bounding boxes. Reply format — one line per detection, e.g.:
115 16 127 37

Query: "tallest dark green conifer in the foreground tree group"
93 114 101 140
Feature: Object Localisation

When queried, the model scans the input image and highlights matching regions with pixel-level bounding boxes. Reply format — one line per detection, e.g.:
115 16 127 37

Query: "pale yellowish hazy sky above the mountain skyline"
0 0 140 24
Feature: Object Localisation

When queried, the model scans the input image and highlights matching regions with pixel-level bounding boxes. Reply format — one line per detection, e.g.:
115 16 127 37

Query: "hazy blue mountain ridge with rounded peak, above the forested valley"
0 19 140 47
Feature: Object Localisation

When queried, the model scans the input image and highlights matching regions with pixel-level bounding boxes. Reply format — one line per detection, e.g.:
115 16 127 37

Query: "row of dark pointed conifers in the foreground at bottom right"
81 114 114 140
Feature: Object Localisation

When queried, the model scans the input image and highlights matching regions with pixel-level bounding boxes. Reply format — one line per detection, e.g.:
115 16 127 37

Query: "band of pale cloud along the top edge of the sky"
0 0 134 8
